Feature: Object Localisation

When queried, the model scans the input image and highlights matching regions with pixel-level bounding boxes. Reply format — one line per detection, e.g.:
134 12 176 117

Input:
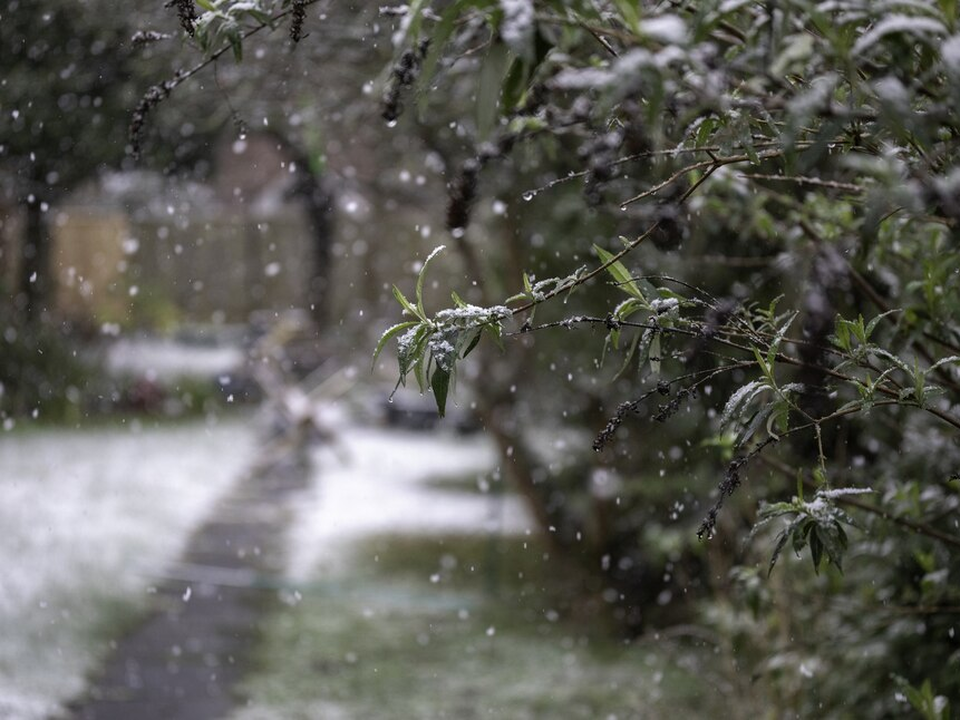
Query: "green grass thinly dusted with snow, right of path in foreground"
233 536 728 720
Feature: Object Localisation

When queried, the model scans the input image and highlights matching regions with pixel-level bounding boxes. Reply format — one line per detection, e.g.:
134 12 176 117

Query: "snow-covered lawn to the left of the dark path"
0 420 253 720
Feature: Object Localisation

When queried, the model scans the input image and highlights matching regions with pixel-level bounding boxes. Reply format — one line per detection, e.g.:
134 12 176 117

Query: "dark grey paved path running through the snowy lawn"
69 460 311 720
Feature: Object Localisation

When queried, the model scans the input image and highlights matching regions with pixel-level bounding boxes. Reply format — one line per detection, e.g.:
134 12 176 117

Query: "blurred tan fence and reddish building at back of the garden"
51 135 323 329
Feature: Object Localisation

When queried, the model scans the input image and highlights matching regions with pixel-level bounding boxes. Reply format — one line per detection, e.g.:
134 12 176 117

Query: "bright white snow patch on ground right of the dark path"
289 427 532 580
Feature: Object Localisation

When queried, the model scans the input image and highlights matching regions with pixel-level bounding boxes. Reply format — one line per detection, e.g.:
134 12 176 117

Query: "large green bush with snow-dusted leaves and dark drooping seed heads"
144 0 960 717
